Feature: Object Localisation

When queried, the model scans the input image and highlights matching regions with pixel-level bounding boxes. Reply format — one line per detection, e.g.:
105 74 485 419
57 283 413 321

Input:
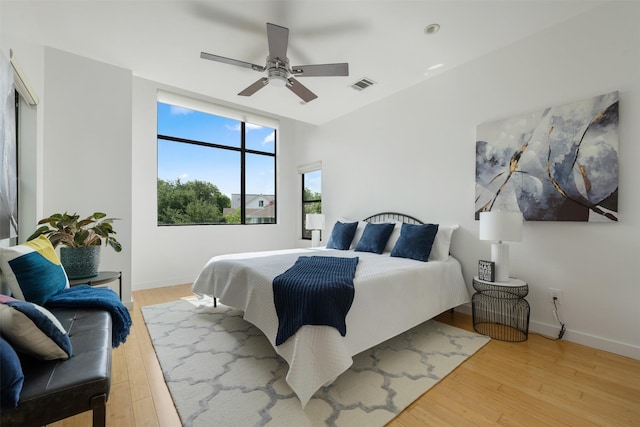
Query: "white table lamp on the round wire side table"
480 211 522 282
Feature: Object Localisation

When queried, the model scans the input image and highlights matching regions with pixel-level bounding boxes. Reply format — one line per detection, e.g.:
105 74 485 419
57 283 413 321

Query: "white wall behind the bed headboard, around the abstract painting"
296 2 640 358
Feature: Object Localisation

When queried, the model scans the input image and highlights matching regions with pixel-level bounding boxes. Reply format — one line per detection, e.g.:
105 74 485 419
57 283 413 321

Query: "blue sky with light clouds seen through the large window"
158 103 275 197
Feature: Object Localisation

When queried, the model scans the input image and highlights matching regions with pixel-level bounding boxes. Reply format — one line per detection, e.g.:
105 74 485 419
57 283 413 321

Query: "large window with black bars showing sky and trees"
157 94 277 225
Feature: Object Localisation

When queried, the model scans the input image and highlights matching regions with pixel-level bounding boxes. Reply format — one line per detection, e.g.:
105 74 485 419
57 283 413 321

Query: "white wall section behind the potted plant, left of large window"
42 48 133 301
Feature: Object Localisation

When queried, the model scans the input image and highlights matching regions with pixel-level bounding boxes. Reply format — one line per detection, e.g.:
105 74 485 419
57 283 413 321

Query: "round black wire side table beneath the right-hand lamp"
471 277 531 342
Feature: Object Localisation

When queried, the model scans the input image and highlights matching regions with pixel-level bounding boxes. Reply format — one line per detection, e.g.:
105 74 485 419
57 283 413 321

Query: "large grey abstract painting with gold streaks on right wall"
475 91 619 222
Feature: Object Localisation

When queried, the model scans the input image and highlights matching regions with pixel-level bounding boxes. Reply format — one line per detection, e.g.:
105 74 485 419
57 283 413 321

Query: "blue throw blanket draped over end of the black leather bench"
45 285 131 348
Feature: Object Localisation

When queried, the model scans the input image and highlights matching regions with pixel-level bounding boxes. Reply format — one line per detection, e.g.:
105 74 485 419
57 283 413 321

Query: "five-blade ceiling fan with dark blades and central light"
200 23 349 102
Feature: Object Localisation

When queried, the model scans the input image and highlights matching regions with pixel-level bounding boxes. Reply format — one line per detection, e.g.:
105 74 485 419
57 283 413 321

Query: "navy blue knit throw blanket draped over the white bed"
273 256 358 345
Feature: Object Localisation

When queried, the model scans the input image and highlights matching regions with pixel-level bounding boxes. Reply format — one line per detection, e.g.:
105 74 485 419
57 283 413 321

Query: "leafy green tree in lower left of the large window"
158 178 231 225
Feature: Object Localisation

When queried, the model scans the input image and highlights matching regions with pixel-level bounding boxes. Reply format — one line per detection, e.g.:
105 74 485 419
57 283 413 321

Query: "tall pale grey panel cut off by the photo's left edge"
0 52 18 239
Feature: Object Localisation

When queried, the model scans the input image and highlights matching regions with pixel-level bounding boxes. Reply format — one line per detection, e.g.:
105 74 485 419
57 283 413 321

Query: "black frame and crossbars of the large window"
156 100 278 227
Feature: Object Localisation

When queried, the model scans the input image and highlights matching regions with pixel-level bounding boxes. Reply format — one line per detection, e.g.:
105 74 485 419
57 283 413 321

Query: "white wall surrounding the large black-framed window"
132 78 300 290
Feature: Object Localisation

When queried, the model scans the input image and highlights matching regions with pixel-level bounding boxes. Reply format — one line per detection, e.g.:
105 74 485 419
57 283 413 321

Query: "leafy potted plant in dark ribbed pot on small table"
28 212 122 279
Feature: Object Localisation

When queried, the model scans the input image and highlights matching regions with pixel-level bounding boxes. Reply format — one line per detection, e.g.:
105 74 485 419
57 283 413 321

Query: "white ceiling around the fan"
1 0 603 124
